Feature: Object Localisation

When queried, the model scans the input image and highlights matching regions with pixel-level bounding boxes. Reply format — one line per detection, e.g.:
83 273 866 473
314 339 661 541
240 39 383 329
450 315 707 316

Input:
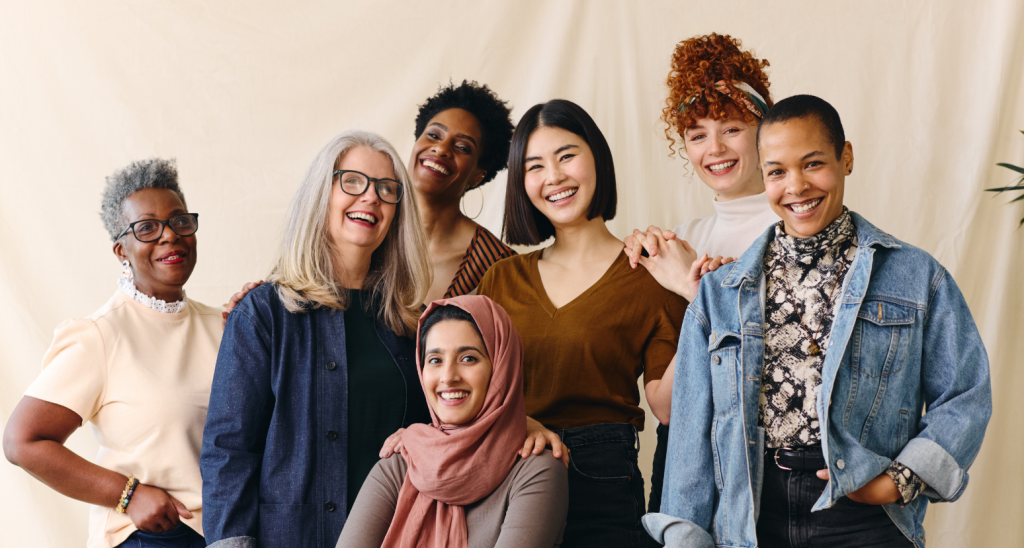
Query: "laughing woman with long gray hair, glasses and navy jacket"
201 131 430 548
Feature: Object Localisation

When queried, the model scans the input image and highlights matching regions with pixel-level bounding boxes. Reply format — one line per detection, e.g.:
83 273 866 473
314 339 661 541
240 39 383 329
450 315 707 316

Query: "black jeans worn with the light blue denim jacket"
757 454 913 548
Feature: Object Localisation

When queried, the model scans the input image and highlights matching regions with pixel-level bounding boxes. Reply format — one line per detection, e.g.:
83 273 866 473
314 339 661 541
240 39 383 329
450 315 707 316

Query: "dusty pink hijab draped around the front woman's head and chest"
382 295 526 548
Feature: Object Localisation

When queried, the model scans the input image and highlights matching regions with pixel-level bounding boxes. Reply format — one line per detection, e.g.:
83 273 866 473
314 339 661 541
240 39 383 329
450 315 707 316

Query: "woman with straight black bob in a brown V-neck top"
479 99 686 547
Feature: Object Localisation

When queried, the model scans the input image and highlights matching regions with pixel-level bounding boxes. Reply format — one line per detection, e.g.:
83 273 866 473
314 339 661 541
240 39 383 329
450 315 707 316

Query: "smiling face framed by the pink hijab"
423 320 493 424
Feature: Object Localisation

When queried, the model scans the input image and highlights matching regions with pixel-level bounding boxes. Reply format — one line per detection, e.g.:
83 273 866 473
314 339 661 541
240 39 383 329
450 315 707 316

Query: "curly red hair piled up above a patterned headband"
662 33 772 154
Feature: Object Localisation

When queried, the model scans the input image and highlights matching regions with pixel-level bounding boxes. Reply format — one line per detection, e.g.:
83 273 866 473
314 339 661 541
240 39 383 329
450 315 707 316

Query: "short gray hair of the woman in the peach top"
99 158 188 242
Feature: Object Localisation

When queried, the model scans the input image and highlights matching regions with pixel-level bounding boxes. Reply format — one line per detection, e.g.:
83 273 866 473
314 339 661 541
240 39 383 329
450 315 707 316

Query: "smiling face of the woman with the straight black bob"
523 127 597 227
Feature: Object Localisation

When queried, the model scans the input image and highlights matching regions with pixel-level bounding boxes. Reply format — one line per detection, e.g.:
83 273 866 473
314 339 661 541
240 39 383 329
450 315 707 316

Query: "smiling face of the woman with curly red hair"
683 118 764 202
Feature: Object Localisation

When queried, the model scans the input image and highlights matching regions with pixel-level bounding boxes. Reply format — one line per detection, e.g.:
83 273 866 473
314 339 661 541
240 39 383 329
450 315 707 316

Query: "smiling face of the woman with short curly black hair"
409 109 486 201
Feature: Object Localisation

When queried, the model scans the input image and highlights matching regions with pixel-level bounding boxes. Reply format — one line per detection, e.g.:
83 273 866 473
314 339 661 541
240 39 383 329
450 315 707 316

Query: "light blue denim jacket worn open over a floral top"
644 213 992 548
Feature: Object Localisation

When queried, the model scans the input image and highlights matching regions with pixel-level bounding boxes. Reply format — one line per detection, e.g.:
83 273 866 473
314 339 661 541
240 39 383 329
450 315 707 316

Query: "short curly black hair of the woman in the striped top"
413 80 515 186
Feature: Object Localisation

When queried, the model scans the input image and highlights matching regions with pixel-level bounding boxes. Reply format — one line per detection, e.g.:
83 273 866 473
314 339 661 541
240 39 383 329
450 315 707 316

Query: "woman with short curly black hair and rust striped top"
409 80 515 302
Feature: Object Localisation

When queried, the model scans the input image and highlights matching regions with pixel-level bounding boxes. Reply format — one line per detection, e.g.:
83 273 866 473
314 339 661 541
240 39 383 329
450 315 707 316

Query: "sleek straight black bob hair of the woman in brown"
504 99 617 246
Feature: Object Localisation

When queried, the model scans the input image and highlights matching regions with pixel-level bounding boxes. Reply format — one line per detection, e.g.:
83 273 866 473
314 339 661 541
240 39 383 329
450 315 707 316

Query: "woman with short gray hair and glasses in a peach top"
3 158 223 548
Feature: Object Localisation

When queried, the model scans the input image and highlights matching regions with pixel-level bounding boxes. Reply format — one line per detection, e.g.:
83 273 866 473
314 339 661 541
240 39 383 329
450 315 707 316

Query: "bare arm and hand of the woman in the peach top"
3 395 193 533
